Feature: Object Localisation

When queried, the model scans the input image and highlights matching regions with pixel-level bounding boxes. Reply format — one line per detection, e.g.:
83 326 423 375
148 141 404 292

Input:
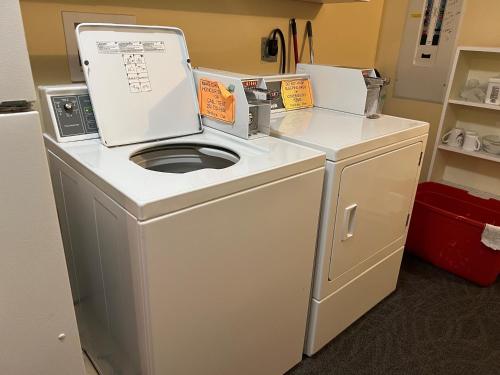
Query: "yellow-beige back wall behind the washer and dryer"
21 0 384 84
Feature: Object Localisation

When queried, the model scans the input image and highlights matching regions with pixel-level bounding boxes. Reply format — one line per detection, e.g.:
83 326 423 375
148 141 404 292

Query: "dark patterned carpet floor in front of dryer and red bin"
287 255 500 375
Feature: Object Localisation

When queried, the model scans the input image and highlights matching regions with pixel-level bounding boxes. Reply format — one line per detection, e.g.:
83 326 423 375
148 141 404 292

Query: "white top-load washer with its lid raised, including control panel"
40 24 325 375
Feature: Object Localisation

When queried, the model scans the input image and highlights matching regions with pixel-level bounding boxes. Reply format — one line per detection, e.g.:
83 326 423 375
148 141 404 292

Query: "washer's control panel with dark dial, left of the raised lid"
39 84 99 142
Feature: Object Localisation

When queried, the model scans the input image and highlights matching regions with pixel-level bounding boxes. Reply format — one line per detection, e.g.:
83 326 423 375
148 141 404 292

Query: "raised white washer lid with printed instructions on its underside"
76 23 202 146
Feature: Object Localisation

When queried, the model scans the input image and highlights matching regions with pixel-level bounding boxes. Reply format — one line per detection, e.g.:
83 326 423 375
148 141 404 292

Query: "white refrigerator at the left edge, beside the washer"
0 0 84 375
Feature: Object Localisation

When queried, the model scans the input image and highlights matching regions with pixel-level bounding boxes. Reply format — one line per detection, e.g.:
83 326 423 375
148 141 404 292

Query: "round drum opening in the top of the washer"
130 143 240 173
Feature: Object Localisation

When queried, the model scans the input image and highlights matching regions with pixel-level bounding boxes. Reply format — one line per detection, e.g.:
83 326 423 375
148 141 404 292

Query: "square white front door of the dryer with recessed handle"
329 142 422 280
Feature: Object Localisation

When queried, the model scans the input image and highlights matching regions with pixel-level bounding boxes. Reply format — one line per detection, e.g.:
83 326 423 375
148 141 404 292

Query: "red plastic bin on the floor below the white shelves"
406 182 500 286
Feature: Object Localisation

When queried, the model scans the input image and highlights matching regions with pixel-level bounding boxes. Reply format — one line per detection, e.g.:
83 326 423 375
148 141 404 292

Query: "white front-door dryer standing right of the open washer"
271 108 429 355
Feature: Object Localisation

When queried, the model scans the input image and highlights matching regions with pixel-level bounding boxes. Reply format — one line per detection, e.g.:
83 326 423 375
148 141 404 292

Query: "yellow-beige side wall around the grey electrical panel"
376 0 500 178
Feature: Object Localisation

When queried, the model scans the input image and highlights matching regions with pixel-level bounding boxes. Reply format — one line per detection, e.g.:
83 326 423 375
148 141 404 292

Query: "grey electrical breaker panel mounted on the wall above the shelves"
394 0 465 103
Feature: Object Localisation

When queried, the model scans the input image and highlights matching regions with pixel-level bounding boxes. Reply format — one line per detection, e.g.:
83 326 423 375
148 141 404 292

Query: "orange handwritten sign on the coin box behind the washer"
198 78 234 124
